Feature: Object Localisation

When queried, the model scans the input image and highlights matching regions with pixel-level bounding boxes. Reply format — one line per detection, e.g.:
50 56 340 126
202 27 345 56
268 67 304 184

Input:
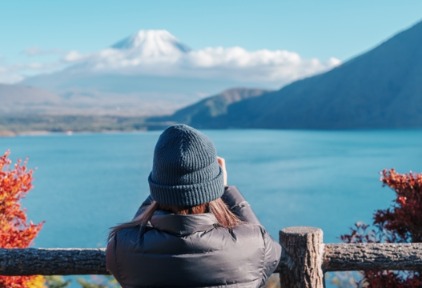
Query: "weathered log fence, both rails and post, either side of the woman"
0 227 422 288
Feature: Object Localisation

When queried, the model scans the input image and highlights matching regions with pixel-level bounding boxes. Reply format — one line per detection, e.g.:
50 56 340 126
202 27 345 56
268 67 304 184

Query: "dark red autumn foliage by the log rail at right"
341 169 422 288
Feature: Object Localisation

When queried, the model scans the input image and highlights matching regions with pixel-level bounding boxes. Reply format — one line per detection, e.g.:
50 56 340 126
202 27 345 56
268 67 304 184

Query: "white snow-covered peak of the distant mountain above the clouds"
112 30 190 57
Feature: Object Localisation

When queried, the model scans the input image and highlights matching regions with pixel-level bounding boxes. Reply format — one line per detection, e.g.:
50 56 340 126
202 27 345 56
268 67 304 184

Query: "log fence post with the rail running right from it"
277 227 422 288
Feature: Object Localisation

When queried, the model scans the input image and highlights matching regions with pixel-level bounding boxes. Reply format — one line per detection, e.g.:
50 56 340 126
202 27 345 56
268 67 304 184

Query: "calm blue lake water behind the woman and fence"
0 130 422 247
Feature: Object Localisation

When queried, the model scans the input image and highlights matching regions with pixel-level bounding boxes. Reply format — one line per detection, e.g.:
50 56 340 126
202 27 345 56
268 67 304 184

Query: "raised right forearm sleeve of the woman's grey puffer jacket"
221 186 261 225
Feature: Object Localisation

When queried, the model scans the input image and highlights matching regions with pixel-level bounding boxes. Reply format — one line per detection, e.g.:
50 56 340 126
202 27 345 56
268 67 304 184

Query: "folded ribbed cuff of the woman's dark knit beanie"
148 168 224 207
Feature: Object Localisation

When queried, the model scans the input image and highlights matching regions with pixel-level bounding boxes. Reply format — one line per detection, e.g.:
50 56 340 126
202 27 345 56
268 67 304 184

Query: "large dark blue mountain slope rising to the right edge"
161 22 422 129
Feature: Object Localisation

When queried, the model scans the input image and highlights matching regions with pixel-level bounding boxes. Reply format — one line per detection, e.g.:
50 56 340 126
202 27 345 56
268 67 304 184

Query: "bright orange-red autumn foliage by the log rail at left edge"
0 152 45 288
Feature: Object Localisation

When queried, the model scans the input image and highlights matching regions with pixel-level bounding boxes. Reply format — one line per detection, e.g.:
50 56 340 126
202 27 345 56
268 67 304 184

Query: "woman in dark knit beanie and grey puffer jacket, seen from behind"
106 125 281 288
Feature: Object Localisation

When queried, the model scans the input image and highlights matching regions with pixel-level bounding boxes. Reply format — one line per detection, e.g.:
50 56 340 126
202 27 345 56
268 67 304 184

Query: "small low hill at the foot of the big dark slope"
147 88 269 128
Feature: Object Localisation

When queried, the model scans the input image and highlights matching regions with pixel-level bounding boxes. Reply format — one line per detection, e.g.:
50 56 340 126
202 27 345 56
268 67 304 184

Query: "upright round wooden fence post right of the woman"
280 227 325 288
